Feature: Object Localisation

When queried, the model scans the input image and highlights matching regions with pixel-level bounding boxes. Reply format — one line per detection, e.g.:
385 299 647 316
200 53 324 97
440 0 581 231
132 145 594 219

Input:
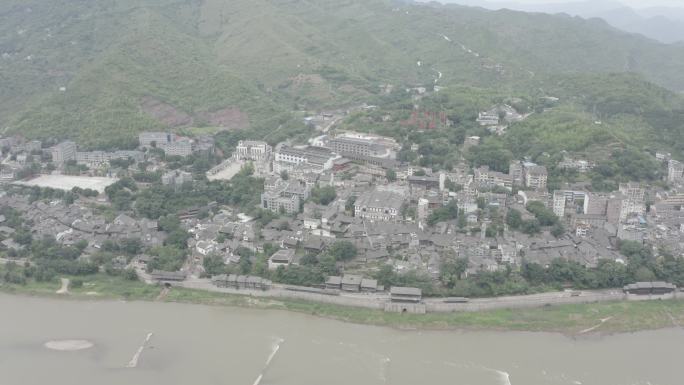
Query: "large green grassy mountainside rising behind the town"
0 0 684 147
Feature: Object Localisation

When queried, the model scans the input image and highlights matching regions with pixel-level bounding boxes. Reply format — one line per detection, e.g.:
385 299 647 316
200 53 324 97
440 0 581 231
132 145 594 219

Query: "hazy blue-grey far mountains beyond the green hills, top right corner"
430 0 684 43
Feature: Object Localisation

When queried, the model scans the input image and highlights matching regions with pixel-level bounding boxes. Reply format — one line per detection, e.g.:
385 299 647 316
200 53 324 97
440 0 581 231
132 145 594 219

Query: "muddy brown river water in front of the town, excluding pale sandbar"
0 295 684 385
